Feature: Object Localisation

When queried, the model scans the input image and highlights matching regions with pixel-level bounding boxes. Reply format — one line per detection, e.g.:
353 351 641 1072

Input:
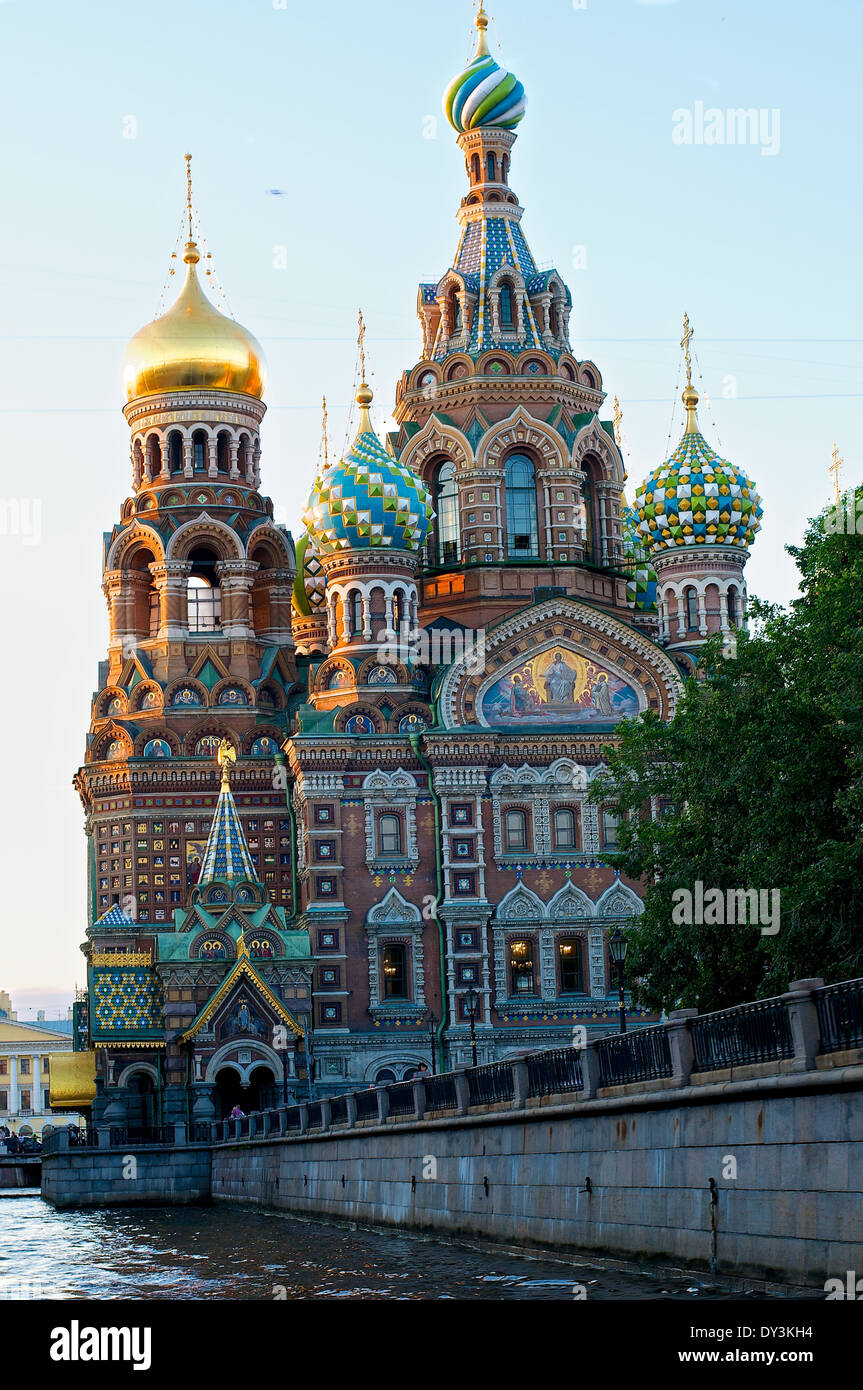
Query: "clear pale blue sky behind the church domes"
0 0 863 1005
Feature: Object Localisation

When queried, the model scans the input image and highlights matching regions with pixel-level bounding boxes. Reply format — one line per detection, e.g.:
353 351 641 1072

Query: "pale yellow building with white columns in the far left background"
0 1011 81 1134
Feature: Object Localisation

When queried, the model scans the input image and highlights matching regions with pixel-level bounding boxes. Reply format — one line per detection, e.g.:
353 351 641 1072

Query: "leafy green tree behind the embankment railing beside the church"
592 489 863 1012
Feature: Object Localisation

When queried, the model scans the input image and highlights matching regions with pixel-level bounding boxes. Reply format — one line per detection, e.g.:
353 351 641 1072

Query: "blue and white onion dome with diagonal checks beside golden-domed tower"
303 382 435 556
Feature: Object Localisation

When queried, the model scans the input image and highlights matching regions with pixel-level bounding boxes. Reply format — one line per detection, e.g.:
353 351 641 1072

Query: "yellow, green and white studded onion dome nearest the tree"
635 385 763 556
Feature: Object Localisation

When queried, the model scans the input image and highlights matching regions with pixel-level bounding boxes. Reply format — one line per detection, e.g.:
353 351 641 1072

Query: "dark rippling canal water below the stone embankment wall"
0 1195 806 1301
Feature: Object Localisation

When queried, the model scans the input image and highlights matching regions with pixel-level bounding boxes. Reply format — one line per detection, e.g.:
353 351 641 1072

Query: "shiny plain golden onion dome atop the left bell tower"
124 240 265 400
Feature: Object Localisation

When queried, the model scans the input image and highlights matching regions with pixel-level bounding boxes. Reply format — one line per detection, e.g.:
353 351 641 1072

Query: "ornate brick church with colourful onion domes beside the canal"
76 0 760 1123
